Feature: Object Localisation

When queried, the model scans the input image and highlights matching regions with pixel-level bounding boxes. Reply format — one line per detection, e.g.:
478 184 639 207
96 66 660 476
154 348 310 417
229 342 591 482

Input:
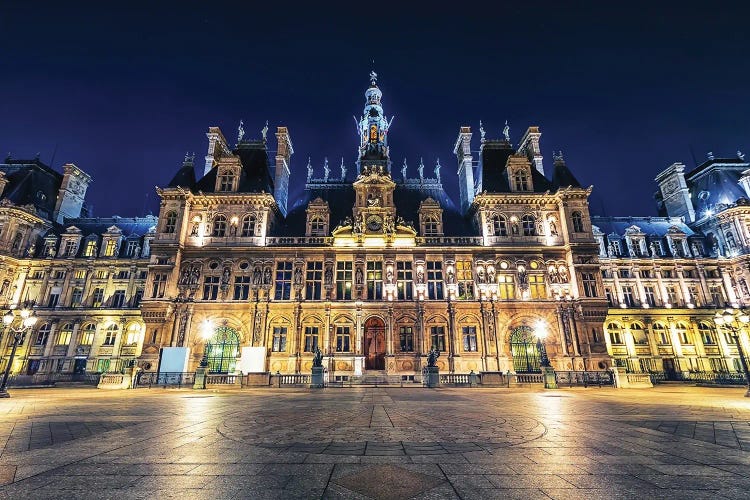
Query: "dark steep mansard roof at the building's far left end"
0 158 63 219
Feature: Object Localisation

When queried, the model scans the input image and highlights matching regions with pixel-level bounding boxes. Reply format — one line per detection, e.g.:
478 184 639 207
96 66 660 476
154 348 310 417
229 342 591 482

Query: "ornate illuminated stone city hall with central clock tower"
0 73 750 383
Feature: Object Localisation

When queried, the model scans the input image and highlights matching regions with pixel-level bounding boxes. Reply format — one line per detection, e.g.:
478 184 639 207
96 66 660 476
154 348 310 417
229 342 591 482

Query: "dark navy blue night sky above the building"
0 1 750 216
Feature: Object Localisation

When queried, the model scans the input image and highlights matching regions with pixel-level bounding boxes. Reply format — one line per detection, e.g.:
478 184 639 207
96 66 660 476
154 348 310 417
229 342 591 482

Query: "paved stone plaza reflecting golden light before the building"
0 385 750 500
